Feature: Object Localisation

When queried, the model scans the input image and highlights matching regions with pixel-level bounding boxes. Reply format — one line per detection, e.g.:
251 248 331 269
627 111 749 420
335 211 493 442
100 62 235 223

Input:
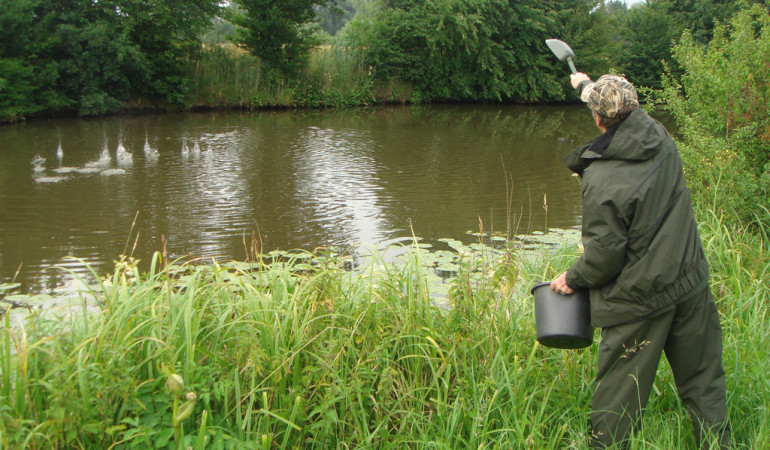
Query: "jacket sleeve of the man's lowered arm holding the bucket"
567 185 628 288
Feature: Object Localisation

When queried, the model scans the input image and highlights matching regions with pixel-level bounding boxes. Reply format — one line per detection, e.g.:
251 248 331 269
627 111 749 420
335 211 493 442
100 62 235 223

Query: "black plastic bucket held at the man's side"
531 283 594 348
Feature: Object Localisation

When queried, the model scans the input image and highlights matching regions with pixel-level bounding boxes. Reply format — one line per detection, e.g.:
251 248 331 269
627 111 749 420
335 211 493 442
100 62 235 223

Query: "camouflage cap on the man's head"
580 75 639 118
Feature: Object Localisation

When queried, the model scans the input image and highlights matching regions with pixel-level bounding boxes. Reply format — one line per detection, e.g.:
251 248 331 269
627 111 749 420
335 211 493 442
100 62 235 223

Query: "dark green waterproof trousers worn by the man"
591 287 730 448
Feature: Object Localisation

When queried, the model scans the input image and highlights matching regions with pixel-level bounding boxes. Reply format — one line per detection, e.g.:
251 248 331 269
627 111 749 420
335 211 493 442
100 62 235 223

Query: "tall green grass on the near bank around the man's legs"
0 209 770 449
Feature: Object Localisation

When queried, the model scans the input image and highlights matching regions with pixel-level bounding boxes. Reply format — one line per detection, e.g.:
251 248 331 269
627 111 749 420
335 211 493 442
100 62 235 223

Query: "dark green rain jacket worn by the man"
564 110 709 327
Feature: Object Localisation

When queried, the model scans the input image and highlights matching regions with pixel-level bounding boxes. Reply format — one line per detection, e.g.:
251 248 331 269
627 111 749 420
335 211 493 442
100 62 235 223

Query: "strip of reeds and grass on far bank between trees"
190 45 412 108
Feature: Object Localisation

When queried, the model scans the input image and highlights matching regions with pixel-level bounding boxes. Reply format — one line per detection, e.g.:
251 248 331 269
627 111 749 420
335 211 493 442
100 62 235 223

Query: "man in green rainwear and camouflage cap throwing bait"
551 73 730 448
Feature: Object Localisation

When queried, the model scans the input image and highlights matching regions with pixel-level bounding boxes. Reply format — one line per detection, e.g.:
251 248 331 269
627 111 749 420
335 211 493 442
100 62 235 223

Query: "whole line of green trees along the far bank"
0 0 766 120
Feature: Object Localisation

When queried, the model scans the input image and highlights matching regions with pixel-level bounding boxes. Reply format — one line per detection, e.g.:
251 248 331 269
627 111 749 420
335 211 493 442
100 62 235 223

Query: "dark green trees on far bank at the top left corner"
0 0 219 117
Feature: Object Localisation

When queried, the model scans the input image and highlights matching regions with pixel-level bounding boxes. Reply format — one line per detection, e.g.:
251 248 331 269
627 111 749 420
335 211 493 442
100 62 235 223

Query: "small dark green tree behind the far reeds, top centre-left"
233 0 332 75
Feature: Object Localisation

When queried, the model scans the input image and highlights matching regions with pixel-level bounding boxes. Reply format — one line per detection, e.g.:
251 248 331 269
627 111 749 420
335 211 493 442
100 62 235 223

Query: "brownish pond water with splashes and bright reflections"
0 105 660 291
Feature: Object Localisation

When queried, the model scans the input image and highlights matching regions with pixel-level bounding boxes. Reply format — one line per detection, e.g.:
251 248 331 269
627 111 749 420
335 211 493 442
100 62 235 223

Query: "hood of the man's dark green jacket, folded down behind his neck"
564 109 668 175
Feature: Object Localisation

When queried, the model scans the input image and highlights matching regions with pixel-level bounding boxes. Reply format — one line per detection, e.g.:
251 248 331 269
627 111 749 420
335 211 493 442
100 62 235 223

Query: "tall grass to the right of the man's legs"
701 209 770 448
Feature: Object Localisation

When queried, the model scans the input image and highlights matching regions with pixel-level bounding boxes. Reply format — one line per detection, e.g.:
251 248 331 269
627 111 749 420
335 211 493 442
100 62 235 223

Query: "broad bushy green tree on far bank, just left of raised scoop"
347 0 557 100
